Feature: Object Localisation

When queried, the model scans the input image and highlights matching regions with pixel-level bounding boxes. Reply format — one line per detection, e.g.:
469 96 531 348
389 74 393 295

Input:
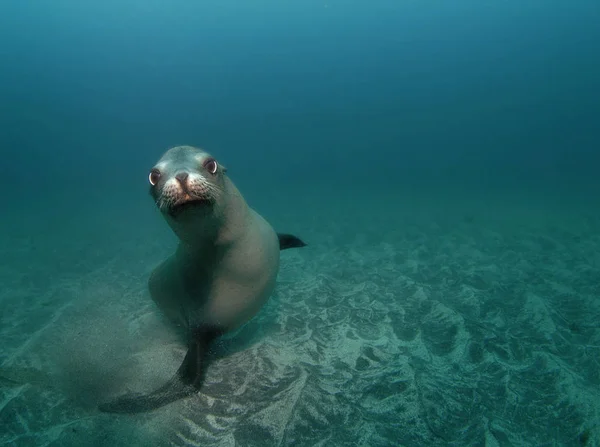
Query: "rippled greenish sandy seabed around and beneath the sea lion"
0 189 600 447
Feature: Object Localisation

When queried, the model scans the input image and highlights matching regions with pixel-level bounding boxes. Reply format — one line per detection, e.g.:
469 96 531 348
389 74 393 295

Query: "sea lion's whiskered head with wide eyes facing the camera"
148 146 225 221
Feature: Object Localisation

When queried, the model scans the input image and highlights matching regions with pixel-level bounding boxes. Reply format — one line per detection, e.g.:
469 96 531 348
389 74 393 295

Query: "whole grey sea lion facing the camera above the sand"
99 146 306 413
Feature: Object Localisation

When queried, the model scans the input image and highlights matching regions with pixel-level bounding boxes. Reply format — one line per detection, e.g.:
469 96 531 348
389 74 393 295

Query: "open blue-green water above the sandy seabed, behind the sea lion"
0 0 600 200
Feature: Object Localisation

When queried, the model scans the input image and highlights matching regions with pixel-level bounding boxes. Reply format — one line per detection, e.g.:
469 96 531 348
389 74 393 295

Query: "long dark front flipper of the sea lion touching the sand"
98 328 222 413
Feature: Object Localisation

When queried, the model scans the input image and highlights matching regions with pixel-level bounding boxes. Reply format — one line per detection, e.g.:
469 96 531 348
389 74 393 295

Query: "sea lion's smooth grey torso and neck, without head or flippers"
149 179 280 332
